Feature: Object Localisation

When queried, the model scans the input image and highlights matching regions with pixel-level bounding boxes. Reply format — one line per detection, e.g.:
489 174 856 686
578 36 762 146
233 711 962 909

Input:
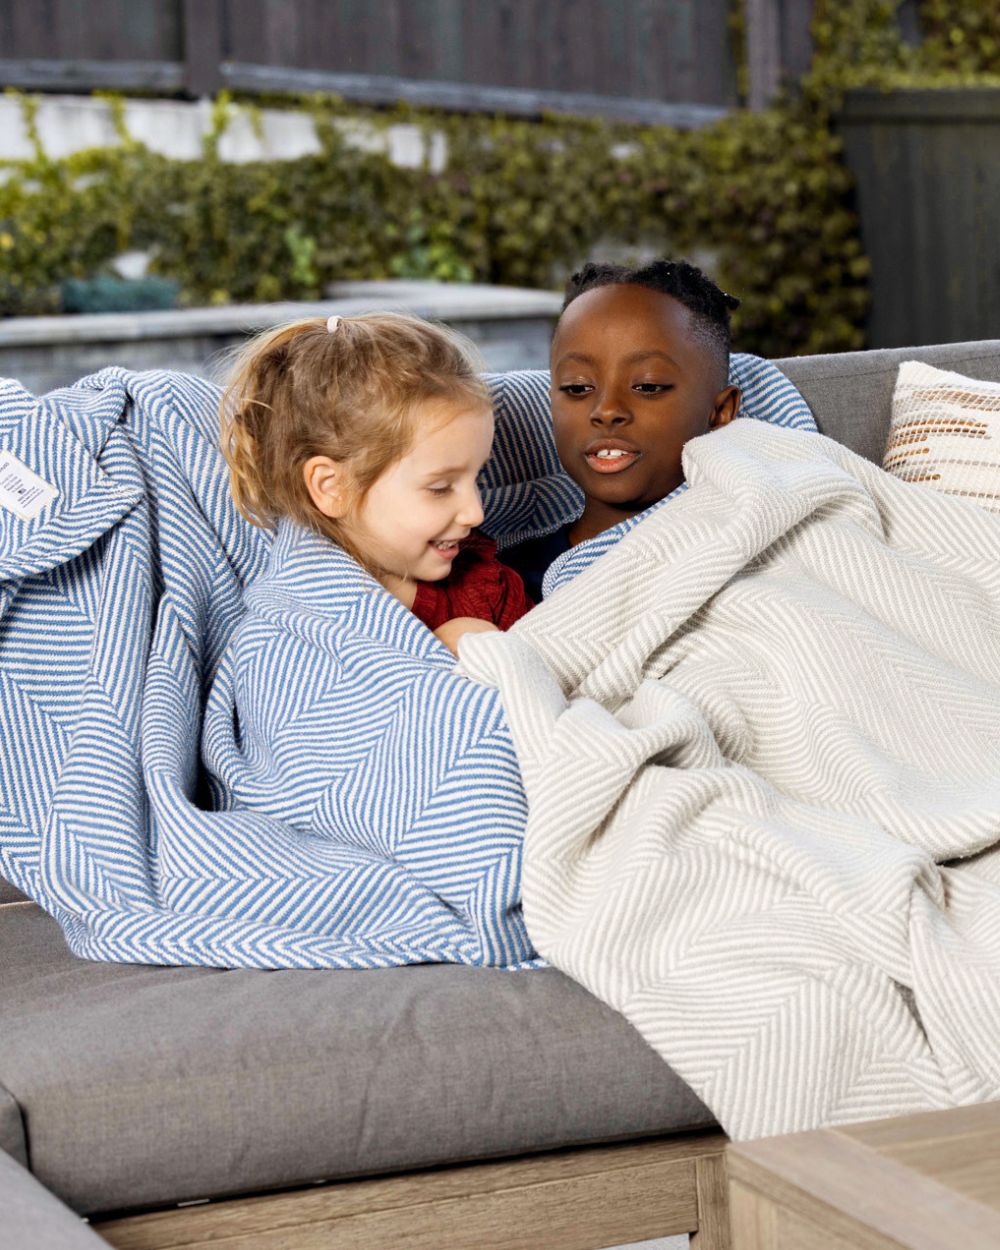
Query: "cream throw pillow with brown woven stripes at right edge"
883 360 1000 513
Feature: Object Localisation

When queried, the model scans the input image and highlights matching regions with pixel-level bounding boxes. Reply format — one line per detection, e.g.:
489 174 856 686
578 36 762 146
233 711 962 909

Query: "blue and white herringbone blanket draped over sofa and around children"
0 358 811 968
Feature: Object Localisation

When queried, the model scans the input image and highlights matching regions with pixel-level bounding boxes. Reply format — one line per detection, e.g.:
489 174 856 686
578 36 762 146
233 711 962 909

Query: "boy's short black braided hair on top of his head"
563 260 740 380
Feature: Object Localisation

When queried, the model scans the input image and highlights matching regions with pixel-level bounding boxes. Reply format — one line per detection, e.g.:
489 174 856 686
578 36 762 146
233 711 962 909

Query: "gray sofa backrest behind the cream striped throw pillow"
775 339 1000 464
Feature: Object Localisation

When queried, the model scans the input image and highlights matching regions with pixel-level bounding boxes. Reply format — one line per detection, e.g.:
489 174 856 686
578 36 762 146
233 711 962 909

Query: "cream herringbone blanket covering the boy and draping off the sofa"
461 421 1000 1139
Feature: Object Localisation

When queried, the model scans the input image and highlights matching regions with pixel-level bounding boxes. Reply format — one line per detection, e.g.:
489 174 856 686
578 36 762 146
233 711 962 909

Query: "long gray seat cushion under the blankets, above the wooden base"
0 904 713 1213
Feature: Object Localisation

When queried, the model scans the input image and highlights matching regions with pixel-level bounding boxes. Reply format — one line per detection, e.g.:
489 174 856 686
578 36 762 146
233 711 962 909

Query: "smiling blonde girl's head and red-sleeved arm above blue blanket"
223 313 531 650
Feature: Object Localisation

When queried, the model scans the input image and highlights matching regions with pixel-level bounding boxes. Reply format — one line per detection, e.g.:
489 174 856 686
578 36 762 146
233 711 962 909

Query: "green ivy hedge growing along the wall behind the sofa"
0 0 1000 356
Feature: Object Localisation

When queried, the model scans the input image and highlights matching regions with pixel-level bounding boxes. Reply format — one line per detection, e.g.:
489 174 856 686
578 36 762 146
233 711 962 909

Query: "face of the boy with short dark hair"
551 285 739 538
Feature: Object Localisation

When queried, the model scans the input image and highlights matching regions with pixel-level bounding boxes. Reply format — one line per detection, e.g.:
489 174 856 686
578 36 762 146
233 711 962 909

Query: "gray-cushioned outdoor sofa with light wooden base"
0 341 1000 1250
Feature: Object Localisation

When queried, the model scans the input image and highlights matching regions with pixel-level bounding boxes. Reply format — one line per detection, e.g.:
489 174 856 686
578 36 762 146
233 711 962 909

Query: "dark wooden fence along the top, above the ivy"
0 0 813 125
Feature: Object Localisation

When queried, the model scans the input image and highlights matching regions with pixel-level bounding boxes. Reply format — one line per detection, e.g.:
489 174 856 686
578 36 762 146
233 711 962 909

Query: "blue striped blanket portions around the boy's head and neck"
483 353 816 596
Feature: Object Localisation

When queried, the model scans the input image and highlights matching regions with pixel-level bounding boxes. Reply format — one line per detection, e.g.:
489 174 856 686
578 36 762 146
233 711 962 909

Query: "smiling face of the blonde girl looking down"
341 403 493 605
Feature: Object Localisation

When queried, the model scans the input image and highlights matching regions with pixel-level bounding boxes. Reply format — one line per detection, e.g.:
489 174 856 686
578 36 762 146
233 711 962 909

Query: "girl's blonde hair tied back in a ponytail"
221 313 490 558
